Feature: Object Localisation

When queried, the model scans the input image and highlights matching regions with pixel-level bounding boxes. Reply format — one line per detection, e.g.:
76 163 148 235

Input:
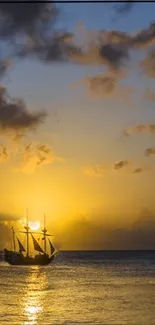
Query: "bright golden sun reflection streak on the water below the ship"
23 267 48 325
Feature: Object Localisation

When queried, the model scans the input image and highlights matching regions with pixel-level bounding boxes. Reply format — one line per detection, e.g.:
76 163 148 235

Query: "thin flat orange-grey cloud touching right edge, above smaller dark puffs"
123 123 155 136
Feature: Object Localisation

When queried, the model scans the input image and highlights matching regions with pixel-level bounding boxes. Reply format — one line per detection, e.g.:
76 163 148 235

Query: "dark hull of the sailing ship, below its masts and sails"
4 249 55 266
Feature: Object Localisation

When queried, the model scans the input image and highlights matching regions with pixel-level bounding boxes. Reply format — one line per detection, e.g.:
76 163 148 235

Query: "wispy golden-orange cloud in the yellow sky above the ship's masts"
16 143 63 173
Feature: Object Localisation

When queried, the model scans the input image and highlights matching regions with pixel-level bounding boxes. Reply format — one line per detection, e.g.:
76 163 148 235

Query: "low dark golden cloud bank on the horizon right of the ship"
56 211 155 250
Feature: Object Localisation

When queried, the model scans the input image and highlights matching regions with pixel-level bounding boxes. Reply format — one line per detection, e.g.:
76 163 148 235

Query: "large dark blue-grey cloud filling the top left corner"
0 1 77 63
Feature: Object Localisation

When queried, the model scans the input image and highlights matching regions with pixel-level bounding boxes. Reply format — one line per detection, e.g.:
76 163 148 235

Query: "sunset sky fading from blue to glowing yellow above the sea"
0 3 155 249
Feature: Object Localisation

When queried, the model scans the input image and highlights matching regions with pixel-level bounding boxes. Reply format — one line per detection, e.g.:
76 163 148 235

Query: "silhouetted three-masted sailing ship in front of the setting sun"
4 216 57 265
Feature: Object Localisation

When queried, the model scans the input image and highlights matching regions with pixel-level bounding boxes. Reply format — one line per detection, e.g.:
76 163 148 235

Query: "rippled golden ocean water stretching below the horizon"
0 252 155 325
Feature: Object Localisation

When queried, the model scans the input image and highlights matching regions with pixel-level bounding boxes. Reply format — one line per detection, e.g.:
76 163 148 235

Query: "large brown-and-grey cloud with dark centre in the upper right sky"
69 21 155 71
